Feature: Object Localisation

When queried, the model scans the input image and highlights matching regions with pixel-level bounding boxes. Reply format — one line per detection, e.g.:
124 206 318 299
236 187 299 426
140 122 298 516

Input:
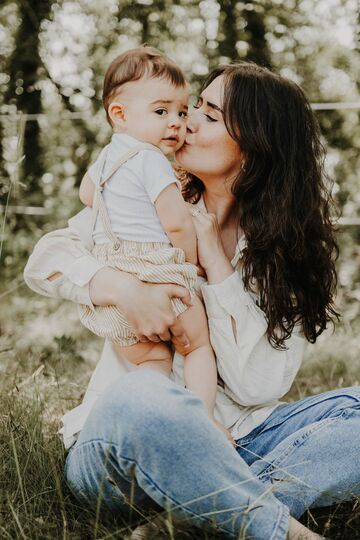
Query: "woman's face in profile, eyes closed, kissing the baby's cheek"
175 75 242 183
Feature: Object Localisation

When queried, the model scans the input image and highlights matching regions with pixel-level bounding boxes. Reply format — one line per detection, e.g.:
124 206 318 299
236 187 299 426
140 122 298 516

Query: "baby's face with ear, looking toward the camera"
110 77 189 156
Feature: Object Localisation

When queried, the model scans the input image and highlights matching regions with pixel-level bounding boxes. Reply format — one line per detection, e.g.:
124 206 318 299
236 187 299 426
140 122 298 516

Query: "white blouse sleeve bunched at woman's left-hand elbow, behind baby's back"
24 211 104 308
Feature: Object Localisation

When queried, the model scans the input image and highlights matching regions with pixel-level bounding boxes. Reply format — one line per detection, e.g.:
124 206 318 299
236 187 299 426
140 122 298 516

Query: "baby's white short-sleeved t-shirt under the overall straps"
88 133 181 244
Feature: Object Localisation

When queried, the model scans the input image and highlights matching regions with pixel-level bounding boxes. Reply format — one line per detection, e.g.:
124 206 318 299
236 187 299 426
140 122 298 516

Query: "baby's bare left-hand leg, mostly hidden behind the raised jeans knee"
113 342 172 377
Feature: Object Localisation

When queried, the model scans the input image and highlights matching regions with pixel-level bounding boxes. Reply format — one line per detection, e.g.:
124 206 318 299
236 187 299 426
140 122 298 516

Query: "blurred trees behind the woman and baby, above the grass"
0 0 360 317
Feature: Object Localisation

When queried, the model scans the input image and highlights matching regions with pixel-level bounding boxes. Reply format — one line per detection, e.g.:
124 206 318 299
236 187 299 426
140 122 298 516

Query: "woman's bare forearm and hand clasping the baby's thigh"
89 267 191 347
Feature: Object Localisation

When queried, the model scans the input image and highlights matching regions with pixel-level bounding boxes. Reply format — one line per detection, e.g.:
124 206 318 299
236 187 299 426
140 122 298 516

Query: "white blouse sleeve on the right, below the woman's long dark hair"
202 271 305 406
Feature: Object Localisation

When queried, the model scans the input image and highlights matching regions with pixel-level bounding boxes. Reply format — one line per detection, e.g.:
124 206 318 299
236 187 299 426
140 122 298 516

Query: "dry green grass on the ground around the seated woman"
0 288 360 540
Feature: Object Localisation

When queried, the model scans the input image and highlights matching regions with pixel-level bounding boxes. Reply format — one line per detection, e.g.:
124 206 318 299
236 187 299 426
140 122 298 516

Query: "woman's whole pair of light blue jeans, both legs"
65 370 360 540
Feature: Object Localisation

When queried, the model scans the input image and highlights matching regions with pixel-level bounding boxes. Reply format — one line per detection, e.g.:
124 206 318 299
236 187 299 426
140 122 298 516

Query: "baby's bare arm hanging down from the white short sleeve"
155 183 197 264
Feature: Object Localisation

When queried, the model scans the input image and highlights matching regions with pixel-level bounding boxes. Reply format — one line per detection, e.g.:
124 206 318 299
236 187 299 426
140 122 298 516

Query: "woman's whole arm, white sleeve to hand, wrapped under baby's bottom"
24 224 191 346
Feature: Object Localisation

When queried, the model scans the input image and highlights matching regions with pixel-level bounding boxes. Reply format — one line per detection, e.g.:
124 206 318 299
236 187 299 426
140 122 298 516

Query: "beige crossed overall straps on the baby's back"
91 143 161 244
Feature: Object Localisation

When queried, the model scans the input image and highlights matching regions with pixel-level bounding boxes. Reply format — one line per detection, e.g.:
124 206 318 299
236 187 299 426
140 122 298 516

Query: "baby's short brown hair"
102 46 186 125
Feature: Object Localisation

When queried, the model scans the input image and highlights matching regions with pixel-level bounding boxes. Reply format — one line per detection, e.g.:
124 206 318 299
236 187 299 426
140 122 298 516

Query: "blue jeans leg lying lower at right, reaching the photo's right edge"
237 387 360 518
